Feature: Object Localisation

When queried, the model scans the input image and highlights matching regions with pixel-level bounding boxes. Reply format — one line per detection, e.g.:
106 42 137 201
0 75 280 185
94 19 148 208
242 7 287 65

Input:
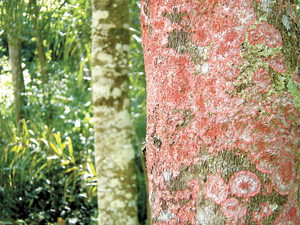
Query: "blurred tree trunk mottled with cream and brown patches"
92 0 138 225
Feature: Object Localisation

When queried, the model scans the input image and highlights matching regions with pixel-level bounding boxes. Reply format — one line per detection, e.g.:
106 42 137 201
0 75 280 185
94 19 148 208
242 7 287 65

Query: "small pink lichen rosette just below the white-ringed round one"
221 198 247 218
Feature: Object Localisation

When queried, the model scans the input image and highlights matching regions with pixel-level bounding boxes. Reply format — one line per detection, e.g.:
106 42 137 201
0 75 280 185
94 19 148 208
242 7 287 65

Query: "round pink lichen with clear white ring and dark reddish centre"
229 171 261 198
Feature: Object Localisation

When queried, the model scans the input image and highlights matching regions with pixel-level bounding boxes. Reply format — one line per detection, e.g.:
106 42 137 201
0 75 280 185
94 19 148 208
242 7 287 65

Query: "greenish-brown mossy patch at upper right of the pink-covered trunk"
245 0 300 102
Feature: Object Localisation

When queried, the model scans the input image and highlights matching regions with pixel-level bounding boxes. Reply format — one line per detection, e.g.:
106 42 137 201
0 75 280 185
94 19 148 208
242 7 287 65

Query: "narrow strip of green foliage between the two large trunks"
129 0 148 224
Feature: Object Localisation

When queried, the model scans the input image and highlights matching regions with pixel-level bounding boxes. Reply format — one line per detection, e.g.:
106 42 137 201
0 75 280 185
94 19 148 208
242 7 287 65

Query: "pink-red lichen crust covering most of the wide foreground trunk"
141 0 299 224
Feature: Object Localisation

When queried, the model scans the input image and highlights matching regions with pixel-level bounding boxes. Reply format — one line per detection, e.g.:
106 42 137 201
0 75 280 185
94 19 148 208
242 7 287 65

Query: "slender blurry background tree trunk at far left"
8 32 25 123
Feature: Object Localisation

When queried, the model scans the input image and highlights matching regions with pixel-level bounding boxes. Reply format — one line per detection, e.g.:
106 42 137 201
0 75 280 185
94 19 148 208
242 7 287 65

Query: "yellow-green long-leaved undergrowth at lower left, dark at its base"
0 119 97 224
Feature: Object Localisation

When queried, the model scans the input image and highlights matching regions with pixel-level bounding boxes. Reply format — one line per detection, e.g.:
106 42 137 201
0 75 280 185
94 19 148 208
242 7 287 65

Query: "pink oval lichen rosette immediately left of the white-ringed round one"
204 174 228 204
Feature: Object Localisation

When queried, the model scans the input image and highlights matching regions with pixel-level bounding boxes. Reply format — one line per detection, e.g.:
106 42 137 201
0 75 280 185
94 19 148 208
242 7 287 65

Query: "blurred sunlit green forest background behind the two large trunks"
0 0 300 224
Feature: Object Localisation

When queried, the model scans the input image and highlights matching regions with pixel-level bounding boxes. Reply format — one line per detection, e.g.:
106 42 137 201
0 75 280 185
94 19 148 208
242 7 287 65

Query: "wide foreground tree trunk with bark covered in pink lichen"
141 0 300 224
